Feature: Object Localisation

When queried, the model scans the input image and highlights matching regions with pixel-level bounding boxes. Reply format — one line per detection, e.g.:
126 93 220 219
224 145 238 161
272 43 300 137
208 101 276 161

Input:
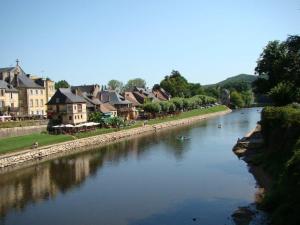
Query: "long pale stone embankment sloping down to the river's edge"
0 110 231 168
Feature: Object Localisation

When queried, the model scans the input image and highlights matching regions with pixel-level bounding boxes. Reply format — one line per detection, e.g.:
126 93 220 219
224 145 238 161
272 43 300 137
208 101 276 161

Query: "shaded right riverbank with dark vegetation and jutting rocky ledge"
233 104 300 225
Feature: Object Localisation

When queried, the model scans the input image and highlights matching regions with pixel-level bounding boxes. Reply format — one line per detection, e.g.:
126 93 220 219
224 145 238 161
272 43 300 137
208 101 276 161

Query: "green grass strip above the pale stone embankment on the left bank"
0 106 228 154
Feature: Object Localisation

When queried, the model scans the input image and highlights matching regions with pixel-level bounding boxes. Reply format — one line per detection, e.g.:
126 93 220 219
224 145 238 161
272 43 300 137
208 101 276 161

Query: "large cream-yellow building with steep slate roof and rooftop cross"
0 60 54 116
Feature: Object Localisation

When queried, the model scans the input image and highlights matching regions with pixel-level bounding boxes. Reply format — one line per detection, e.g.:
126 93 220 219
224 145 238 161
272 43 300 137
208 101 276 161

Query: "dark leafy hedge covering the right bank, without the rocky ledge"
254 106 300 225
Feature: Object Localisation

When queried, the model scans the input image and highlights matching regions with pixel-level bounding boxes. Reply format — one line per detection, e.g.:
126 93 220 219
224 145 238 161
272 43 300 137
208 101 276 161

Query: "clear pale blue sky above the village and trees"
0 0 300 85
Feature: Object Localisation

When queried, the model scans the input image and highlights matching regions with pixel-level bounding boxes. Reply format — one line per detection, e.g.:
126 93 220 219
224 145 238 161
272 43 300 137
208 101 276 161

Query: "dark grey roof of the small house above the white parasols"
47 88 86 105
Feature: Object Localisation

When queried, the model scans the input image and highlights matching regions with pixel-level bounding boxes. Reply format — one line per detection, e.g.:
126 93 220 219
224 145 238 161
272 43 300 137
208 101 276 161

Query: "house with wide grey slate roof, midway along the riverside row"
100 90 138 120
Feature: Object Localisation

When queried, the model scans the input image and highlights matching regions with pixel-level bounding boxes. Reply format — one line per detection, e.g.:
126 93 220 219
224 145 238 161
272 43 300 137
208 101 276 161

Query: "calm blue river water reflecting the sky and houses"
0 108 260 225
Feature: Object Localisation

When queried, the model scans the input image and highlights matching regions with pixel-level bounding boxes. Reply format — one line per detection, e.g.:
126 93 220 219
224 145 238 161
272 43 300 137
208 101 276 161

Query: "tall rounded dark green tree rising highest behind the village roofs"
160 70 190 97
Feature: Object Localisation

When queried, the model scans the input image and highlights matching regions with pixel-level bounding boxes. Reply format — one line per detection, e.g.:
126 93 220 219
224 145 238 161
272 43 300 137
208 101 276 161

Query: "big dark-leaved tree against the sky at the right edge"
253 35 300 104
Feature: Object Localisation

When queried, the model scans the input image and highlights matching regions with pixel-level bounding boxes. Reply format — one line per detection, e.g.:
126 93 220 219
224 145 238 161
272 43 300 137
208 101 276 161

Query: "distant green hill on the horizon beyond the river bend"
203 74 257 88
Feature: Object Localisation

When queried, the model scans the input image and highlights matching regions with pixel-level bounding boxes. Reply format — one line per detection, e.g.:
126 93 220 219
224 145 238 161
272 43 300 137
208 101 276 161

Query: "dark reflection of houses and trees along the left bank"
0 127 191 218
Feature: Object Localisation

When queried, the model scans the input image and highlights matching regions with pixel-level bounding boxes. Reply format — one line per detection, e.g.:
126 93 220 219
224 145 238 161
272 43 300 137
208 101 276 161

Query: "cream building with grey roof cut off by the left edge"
0 80 19 115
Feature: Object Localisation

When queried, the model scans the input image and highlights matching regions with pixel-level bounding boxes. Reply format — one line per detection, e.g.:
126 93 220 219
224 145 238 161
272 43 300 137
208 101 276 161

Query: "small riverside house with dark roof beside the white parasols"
47 88 87 125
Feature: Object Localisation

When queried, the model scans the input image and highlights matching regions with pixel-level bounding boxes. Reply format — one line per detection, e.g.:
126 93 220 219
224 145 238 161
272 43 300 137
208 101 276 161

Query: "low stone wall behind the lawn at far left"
0 125 47 139
